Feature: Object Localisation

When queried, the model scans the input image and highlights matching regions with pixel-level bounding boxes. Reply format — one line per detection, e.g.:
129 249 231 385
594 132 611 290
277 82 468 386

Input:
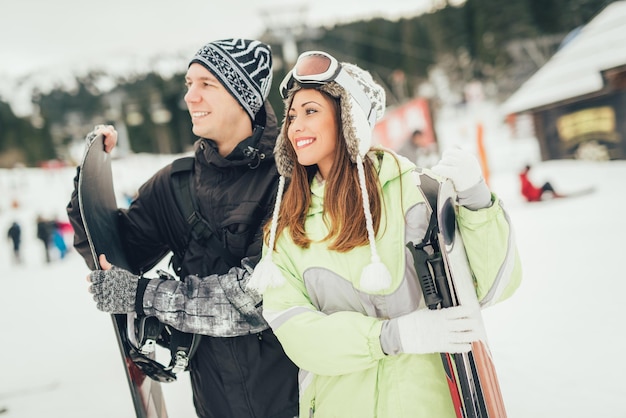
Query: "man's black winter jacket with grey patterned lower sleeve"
67 102 298 418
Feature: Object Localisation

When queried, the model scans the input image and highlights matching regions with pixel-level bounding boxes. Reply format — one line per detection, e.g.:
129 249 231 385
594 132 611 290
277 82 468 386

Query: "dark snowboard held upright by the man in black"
77 135 167 418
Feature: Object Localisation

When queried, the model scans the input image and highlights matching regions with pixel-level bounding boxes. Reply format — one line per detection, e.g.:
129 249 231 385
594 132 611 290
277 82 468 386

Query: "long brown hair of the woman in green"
266 91 383 252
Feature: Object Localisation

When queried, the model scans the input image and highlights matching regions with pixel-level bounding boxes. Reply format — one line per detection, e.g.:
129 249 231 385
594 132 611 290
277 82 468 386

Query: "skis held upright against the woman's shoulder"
409 173 507 418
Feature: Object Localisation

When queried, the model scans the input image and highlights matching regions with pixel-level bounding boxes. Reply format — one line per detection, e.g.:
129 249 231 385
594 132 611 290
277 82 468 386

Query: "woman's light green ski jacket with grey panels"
263 153 521 418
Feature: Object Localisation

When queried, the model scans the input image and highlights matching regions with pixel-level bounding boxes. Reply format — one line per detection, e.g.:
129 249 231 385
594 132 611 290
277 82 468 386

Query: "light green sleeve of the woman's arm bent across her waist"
263 242 385 376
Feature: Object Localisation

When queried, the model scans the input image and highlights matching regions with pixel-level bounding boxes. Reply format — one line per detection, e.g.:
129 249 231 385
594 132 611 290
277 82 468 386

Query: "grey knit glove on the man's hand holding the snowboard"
89 266 139 314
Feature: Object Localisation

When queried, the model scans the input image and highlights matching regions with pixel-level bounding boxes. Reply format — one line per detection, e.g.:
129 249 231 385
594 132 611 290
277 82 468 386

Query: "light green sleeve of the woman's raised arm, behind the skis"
457 194 522 307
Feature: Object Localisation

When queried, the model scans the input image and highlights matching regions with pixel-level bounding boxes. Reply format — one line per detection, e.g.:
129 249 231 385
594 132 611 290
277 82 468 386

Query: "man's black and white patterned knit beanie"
189 39 272 120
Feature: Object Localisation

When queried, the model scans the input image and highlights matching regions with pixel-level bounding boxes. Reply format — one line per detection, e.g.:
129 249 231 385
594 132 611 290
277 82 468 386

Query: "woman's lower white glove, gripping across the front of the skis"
391 306 483 354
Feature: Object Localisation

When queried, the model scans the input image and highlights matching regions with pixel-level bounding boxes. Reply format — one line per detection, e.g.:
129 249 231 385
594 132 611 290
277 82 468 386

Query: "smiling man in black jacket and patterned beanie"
68 39 298 418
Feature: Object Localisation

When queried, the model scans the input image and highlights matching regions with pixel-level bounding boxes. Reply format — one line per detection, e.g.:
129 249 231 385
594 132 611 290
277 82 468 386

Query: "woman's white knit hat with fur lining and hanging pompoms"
248 57 391 292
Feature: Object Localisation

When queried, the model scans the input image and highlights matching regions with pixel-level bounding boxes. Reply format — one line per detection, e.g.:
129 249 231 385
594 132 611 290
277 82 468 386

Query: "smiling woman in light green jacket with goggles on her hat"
250 51 521 418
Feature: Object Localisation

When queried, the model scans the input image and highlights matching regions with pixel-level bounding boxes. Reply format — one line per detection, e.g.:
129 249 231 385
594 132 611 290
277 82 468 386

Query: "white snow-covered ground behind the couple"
0 127 626 418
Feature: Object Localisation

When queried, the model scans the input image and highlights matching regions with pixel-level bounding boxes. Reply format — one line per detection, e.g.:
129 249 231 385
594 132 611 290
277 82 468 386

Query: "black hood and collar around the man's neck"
194 101 278 168
